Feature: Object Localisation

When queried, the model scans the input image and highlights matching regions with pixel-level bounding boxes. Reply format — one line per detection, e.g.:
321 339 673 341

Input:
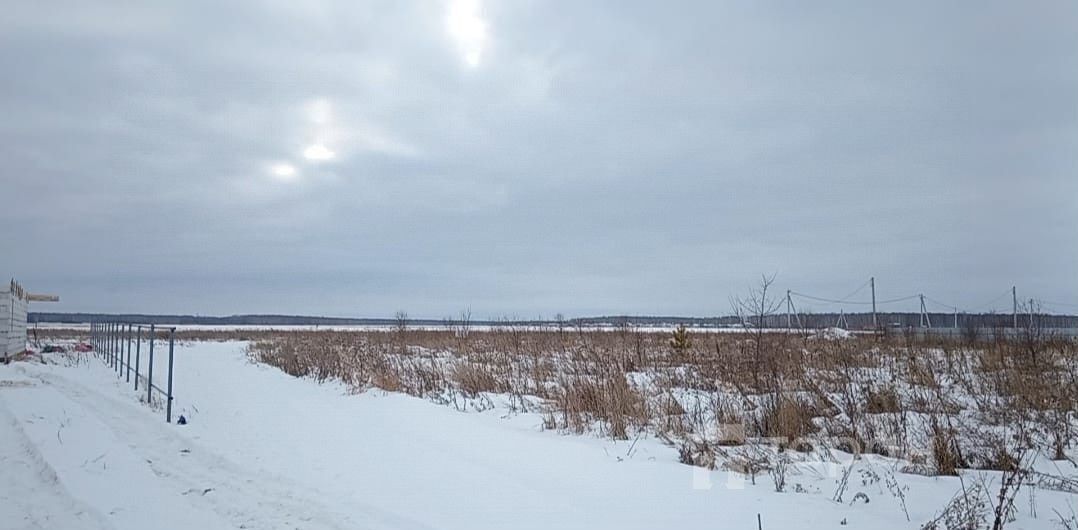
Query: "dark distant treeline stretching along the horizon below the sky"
27 312 1078 330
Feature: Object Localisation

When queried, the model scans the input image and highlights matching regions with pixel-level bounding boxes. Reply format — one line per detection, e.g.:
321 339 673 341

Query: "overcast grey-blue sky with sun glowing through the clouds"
0 0 1078 318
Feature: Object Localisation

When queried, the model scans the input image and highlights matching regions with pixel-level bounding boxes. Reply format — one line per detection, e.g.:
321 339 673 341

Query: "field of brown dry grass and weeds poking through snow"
37 324 1078 474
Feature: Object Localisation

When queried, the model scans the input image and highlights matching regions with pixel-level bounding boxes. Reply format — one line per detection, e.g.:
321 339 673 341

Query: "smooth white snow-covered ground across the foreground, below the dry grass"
0 343 1078 530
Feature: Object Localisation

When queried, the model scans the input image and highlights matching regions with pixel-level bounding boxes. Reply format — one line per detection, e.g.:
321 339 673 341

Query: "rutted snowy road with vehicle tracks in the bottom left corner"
0 359 399 529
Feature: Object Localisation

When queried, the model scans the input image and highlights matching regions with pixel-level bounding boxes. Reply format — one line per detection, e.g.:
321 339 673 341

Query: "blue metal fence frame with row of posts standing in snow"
89 322 176 423
